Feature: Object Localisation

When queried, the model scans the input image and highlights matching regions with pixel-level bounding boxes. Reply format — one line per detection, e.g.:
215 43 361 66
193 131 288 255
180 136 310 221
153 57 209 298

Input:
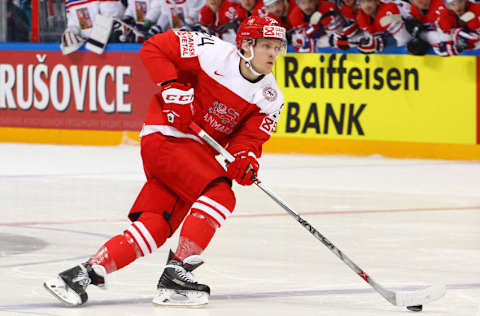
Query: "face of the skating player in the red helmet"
252 38 284 75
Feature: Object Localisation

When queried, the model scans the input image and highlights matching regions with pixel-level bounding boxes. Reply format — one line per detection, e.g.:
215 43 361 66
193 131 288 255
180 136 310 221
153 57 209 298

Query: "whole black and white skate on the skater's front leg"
153 250 210 306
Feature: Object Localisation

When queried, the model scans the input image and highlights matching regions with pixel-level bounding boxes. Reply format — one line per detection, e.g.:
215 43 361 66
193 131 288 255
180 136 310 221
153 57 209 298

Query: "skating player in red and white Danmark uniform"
44 16 286 306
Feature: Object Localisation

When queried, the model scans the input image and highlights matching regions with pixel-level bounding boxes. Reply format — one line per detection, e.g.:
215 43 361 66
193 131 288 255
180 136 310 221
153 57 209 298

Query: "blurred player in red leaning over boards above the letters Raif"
288 0 343 52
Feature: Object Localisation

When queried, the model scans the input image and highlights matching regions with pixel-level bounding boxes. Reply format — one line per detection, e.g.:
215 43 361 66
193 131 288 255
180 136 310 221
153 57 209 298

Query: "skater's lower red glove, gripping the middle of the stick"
227 150 260 185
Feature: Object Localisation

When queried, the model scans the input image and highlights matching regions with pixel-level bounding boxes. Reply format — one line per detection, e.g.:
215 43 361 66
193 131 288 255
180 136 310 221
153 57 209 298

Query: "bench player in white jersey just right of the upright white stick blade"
118 0 162 42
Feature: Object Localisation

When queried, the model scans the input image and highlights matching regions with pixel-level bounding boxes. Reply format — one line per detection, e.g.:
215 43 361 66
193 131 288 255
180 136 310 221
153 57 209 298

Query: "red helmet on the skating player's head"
236 16 287 49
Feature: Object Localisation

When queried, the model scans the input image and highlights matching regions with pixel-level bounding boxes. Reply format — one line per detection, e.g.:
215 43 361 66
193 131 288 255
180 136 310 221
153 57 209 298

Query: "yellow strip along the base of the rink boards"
0 127 480 160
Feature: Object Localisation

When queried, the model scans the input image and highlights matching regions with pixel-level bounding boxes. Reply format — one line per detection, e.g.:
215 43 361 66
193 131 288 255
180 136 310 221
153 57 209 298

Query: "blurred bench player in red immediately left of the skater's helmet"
200 0 247 43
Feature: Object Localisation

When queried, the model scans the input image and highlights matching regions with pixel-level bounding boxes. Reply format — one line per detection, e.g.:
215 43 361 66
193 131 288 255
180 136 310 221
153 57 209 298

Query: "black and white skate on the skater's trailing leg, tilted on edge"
43 262 107 306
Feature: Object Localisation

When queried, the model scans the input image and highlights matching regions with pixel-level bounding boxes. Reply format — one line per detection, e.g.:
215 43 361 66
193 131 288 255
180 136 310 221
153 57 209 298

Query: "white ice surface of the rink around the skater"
0 144 480 316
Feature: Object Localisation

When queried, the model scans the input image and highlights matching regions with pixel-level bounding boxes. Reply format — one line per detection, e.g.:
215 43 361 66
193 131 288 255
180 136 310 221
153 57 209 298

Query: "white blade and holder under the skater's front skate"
152 288 209 307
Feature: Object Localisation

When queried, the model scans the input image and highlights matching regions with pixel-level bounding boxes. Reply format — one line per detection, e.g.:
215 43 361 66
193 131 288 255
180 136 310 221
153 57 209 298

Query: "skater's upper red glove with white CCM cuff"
162 82 194 132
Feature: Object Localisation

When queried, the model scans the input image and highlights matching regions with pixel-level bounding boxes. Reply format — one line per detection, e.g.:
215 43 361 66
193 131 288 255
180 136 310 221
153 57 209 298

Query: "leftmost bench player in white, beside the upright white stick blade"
60 0 125 55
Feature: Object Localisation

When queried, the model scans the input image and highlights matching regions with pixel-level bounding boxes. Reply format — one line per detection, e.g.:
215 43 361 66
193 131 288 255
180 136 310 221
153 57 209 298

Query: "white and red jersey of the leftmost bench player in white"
65 0 125 38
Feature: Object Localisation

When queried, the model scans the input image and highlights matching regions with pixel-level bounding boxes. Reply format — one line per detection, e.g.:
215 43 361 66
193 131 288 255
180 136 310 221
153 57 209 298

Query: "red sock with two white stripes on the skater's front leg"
175 181 235 261
